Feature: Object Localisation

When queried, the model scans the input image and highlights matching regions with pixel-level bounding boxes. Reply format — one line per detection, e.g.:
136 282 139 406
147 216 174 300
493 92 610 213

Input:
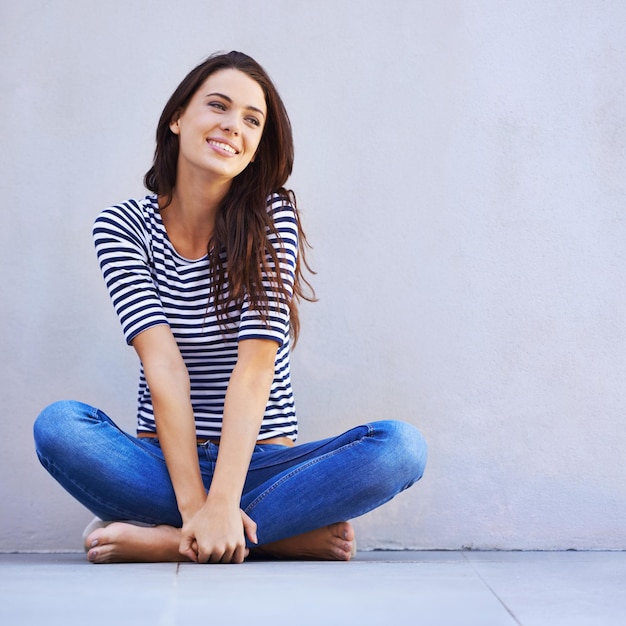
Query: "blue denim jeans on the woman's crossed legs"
34 401 426 545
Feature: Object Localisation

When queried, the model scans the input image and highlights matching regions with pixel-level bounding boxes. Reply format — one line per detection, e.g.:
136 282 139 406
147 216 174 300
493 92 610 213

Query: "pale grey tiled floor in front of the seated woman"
0 552 626 626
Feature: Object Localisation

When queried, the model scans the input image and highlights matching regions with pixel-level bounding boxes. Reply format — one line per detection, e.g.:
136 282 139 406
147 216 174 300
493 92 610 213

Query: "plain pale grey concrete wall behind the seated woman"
0 0 626 551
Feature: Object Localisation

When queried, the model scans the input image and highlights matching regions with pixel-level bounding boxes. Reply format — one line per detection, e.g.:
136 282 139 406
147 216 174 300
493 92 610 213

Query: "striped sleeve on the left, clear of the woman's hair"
93 202 168 344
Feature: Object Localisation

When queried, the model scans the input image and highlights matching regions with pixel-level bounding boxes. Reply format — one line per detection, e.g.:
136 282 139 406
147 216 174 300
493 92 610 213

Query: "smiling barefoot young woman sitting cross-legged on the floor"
34 52 426 563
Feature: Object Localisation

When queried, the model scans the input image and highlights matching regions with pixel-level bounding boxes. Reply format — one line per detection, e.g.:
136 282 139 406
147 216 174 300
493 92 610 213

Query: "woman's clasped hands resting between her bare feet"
179 496 257 563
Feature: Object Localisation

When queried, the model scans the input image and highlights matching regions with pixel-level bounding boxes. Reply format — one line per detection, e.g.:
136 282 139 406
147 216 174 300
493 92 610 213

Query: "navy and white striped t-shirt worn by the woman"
93 194 298 440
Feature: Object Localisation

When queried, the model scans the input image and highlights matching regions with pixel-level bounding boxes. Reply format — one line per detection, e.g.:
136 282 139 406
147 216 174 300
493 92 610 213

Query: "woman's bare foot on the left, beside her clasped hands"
85 522 188 563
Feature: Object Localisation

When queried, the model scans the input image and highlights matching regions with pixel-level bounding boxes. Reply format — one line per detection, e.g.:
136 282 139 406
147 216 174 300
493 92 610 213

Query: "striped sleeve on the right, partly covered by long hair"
238 195 298 345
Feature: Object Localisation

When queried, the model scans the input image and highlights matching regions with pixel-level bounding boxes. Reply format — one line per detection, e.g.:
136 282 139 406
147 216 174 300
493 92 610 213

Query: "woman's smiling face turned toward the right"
170 69 267 182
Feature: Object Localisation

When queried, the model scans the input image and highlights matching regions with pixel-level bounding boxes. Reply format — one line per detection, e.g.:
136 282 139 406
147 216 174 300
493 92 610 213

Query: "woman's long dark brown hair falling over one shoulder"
144 51 315 344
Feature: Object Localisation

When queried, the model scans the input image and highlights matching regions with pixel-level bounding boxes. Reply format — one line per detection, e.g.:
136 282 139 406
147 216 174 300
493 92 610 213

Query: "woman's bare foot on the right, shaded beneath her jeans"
251 522 356 561
